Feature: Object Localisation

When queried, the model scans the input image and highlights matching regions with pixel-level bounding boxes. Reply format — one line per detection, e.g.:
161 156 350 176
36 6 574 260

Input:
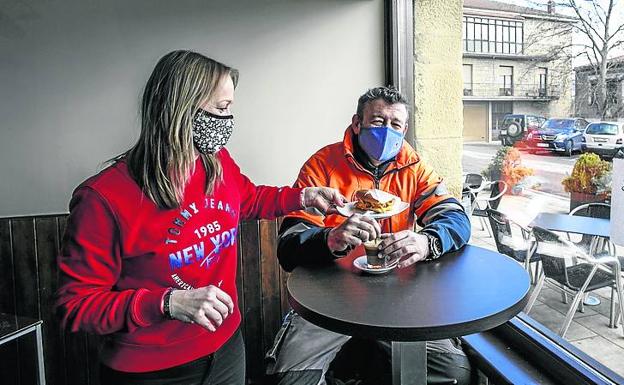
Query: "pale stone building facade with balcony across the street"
462 0 574 141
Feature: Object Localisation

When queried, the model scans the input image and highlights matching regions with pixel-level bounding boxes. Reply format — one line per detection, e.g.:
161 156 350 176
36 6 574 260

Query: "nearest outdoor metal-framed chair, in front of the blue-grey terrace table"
525 226 624 337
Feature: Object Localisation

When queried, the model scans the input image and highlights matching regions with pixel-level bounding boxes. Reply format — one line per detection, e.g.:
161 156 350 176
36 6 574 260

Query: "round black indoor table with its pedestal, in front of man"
287 245 530 384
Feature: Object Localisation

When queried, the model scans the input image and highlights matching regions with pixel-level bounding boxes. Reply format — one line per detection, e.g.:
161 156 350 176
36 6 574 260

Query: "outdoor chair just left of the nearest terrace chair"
486 209 539 283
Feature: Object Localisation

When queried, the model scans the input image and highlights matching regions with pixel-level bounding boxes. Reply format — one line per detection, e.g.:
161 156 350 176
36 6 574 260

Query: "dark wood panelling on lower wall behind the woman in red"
0 215 287 385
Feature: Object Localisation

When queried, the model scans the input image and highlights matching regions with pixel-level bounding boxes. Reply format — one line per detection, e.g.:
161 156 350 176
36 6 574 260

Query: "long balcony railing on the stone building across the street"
464 83 560 100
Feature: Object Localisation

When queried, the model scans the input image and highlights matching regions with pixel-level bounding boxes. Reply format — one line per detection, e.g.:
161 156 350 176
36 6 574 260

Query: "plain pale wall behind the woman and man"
0 0 384 216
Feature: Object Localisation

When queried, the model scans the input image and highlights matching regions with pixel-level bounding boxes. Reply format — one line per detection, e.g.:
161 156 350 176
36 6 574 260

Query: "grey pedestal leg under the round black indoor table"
392 341 427 385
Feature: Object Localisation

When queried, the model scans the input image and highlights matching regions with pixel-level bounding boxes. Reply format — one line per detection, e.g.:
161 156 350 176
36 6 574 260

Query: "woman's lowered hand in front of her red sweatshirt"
169 285 234 332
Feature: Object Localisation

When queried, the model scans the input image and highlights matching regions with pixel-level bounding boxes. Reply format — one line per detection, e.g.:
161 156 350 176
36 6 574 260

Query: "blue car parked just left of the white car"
526 118 589 156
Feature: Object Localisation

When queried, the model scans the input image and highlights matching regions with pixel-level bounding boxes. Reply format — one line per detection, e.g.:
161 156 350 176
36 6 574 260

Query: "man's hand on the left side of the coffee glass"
327 214 381 252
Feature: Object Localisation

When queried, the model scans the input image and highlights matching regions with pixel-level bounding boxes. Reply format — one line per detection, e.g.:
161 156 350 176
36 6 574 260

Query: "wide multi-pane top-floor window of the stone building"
463 16 524 55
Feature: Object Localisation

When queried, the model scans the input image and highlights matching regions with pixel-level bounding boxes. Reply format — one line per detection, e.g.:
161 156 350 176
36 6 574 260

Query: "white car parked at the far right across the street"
583 122 624 158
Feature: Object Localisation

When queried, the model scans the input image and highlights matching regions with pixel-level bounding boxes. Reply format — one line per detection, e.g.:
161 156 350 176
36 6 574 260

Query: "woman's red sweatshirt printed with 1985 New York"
57 149 301 372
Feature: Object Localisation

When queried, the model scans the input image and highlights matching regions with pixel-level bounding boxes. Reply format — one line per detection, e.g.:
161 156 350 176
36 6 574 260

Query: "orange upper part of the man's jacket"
288 126 452 232
